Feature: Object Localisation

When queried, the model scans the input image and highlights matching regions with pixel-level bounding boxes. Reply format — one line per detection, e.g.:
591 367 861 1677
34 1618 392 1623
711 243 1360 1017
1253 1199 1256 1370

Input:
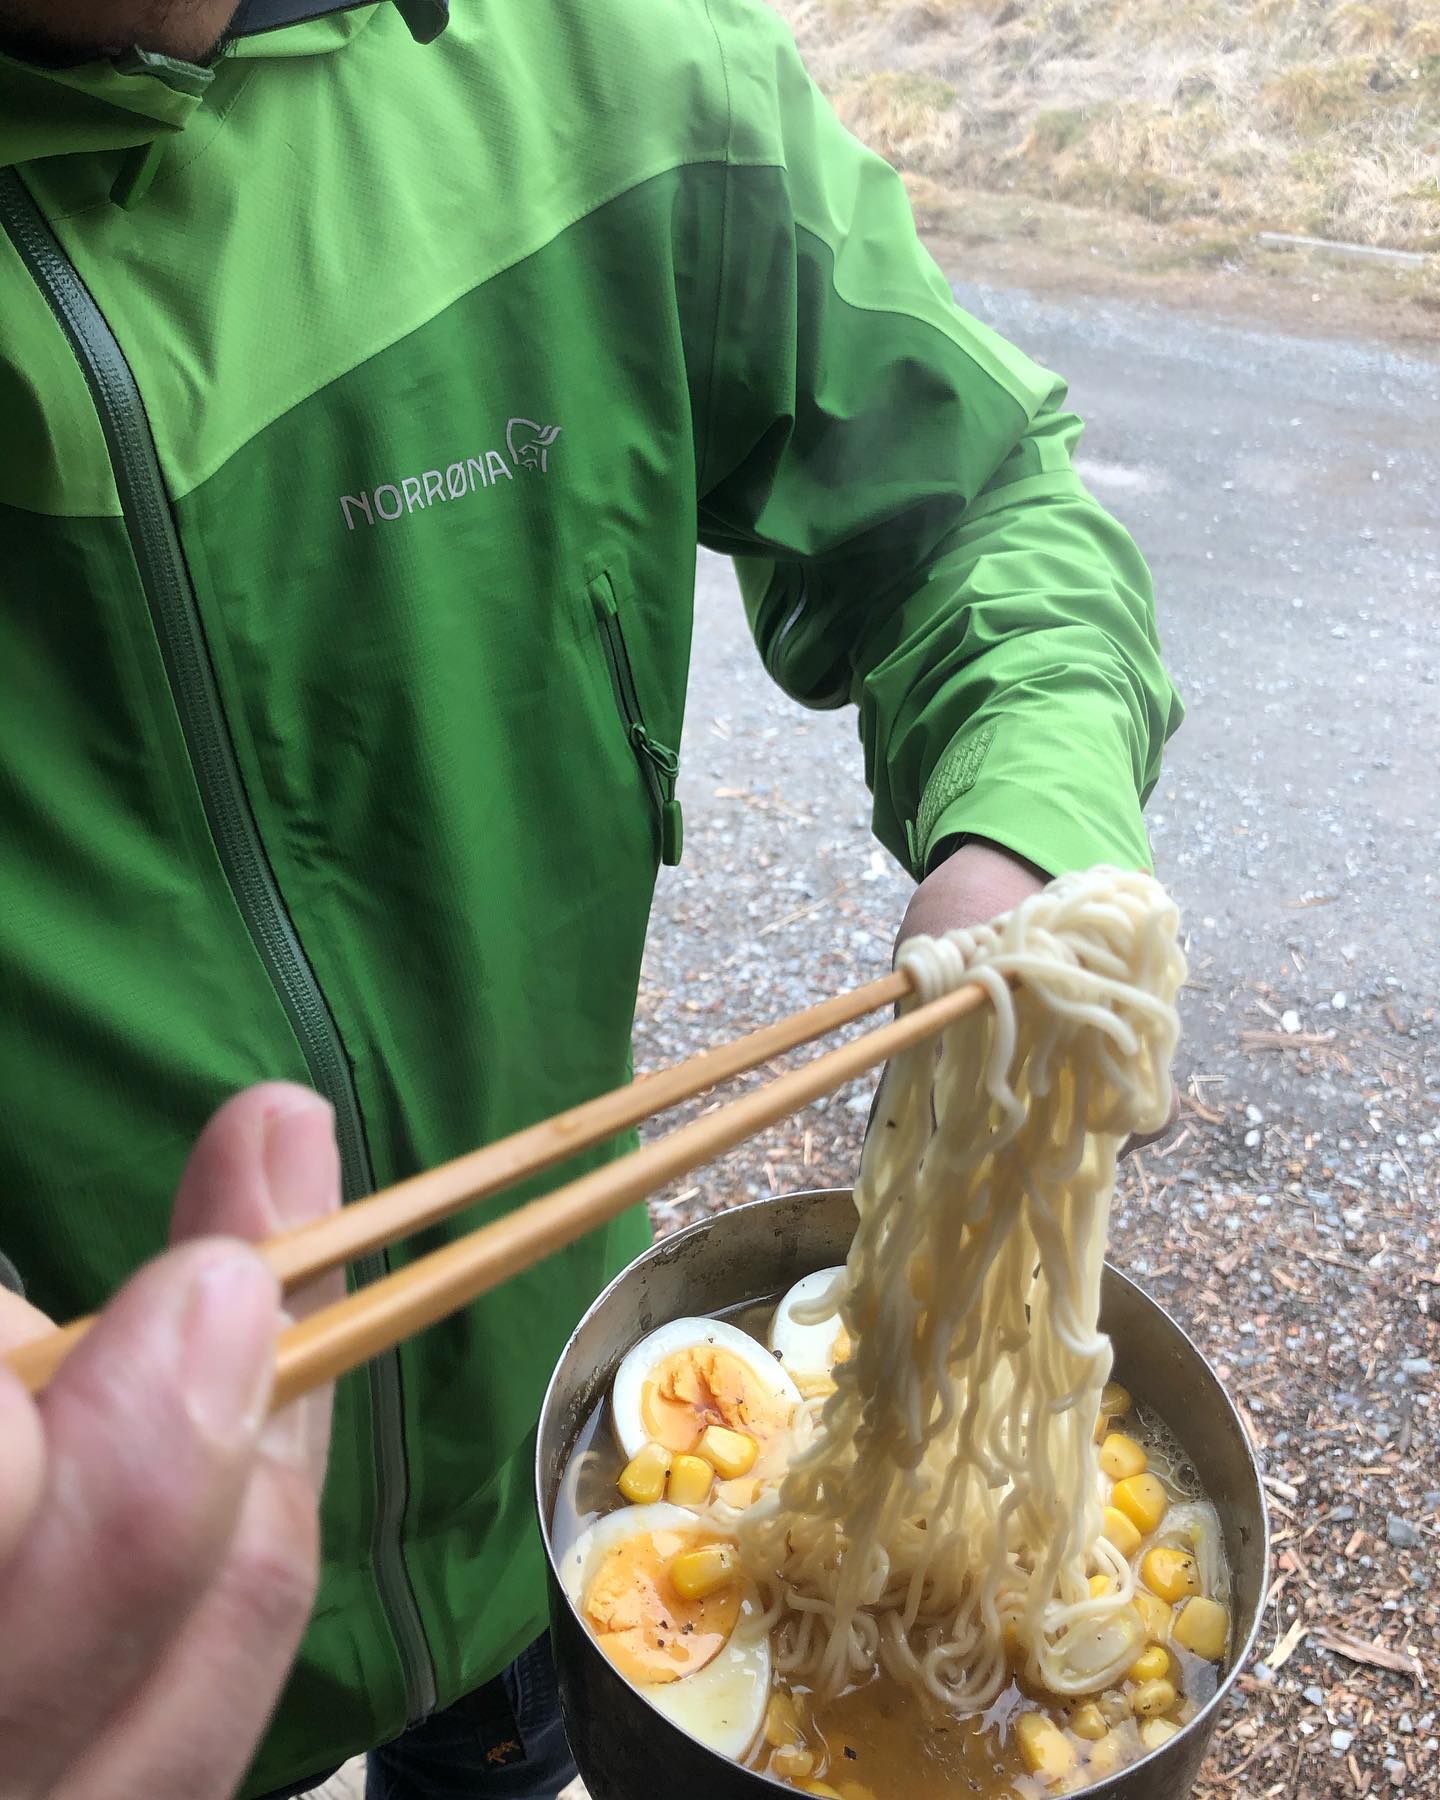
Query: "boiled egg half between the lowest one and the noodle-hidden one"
610 1319 801 1481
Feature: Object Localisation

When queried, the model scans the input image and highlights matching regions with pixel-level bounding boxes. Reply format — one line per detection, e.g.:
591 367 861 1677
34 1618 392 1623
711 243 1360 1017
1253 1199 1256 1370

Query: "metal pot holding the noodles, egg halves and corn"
535 1188 1269 1800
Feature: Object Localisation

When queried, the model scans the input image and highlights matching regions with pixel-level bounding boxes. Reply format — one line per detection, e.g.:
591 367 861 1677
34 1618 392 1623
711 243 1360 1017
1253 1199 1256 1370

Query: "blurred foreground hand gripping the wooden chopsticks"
0 1082 340 1800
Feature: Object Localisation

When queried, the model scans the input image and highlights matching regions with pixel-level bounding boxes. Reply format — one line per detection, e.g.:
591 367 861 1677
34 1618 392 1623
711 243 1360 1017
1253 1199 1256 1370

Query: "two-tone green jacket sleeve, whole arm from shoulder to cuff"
698 0 1181 878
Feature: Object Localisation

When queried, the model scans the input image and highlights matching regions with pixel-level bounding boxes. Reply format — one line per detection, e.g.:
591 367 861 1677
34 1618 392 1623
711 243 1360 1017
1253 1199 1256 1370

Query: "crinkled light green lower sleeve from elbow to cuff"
857 414 1181 878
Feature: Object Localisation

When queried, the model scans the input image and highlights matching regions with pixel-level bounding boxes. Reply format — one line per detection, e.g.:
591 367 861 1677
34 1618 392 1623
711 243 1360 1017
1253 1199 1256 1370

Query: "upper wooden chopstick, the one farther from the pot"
7 972 911 1393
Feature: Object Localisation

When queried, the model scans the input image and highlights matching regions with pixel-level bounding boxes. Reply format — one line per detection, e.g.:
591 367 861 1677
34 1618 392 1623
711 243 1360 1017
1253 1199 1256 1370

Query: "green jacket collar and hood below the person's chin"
0 0 446 169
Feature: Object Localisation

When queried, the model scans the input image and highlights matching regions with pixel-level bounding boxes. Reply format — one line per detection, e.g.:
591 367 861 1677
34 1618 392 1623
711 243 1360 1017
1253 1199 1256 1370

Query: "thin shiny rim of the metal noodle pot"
535 1188 1271 1800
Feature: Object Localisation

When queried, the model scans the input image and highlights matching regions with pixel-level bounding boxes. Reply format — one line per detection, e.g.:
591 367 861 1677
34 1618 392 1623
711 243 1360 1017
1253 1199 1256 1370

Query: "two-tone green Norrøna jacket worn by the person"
0 0 1177 1791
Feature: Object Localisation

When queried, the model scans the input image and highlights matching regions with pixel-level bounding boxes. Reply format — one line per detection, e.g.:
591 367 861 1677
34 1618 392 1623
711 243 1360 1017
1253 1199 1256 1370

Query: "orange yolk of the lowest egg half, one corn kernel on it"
585 1532 740 1687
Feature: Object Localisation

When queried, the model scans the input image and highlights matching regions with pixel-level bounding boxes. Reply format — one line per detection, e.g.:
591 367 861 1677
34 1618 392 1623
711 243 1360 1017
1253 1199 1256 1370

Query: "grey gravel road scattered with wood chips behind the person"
637 288 1440 1800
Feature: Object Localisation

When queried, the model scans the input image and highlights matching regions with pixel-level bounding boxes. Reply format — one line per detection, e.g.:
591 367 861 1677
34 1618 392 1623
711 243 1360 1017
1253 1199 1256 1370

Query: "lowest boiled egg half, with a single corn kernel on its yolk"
560 1501 770 1759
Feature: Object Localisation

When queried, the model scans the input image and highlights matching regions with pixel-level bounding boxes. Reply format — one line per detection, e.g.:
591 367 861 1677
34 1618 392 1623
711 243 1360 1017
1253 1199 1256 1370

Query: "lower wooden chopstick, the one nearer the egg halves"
9 983 985 1411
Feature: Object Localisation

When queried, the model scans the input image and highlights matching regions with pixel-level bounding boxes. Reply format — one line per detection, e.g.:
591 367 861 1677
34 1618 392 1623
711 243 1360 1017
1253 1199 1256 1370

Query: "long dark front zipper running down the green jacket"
0 169 436 1721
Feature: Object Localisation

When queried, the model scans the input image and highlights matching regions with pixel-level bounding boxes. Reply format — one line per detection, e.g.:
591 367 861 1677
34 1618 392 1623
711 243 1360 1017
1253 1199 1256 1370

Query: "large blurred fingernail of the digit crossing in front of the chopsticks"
180 1246 279 1449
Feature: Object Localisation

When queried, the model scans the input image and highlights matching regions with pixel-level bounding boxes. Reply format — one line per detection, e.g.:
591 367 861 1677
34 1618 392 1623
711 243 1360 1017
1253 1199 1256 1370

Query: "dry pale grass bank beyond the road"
776 0 1440 250
